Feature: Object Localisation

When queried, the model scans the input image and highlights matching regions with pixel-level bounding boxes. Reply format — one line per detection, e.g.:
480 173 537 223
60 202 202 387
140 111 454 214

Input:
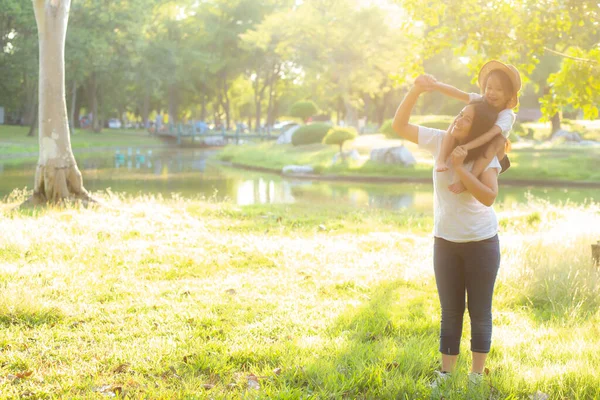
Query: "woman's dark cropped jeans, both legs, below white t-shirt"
433 235 500 355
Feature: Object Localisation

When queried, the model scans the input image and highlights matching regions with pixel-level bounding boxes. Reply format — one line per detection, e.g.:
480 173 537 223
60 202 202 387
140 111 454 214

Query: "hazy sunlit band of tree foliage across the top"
0 0 600 130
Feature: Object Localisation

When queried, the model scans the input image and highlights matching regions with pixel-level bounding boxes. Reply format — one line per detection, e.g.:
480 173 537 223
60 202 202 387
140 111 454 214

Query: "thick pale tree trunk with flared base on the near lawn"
26 0 93 205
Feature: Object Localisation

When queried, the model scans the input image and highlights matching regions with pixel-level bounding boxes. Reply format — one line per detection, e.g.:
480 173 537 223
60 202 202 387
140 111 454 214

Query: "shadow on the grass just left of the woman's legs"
279 281 439 399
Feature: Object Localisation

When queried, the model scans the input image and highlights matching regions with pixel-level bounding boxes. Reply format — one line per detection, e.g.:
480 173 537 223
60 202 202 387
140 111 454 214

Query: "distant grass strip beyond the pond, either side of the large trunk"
0 125 164 157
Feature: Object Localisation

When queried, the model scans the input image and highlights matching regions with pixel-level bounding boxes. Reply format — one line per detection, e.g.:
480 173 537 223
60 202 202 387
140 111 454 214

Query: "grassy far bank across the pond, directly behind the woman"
219 129 600 182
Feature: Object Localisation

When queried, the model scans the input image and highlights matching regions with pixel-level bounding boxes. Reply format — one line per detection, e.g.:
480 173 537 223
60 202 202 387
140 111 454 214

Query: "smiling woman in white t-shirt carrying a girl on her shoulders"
392 78 501 394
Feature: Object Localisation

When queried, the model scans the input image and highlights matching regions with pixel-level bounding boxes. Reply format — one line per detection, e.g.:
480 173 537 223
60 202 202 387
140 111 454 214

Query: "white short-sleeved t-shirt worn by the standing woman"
419 126 502 243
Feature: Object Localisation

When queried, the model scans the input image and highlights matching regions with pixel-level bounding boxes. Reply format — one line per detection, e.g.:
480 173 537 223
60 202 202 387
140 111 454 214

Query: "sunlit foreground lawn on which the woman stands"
0 194 600 399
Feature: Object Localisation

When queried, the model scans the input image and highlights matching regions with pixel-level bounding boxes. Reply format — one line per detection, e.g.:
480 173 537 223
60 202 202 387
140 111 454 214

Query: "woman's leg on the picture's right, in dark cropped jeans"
462 235 500 373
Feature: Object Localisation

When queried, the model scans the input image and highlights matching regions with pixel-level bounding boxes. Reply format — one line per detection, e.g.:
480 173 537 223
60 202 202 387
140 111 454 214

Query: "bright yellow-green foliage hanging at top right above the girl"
397 0 600 130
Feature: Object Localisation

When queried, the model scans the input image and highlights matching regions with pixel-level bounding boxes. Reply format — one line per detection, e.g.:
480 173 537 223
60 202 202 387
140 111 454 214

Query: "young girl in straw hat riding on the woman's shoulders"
417 60 521 194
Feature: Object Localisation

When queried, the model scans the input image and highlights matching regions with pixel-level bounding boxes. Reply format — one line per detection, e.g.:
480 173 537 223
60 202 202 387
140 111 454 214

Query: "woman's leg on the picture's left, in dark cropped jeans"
433 238 465 372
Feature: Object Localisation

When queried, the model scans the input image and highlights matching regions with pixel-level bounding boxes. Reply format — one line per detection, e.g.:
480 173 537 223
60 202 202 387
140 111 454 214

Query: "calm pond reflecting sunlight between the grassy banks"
0 148 598 212
